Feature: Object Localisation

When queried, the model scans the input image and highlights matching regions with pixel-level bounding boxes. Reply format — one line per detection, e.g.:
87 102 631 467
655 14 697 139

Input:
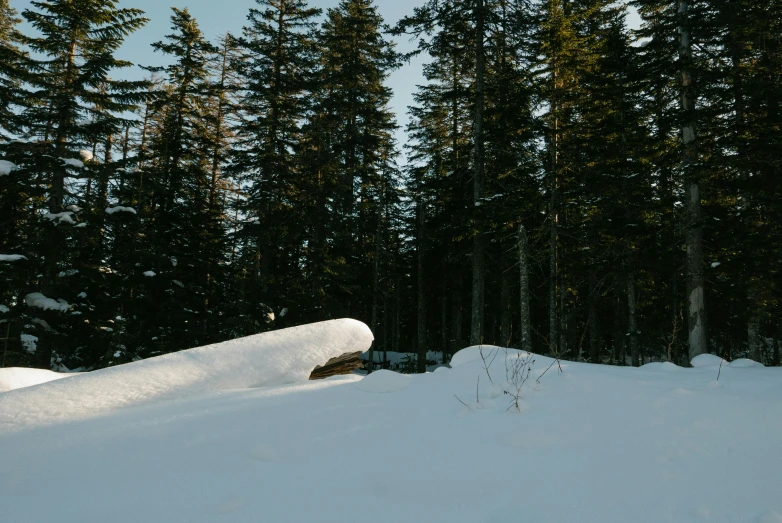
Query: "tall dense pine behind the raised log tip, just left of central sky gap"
304 0 398 332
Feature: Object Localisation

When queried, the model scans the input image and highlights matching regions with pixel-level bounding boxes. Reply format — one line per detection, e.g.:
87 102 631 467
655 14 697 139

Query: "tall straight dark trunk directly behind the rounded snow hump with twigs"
470 0 486 345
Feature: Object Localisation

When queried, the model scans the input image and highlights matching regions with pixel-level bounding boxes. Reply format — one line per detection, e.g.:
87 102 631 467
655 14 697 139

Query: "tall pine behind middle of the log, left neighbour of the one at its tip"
231 0 321 332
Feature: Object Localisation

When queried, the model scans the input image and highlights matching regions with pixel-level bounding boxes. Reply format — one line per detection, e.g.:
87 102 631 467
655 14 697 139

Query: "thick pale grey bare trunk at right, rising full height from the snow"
679 0 709 360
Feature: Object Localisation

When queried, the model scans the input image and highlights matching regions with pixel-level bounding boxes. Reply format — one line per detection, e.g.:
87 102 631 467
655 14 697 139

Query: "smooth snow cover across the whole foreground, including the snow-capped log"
0 321 782 523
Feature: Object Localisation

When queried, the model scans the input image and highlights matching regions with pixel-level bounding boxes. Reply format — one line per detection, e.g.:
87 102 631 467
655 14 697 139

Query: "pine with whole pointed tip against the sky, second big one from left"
135 8 225 355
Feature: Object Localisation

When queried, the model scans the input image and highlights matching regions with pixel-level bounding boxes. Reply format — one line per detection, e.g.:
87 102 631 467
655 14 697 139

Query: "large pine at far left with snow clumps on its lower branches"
3 0 147 368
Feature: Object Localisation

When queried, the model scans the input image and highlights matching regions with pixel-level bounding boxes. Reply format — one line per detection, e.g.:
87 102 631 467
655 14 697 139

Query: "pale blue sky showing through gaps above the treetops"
10 0 632 146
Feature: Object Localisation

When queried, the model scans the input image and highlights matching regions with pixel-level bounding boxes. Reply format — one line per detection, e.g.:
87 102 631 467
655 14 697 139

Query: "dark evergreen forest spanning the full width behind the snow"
0 0 782 369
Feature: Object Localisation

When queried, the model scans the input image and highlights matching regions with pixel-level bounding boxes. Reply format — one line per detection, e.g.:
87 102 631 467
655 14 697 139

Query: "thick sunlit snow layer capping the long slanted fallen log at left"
0 319 373 433
